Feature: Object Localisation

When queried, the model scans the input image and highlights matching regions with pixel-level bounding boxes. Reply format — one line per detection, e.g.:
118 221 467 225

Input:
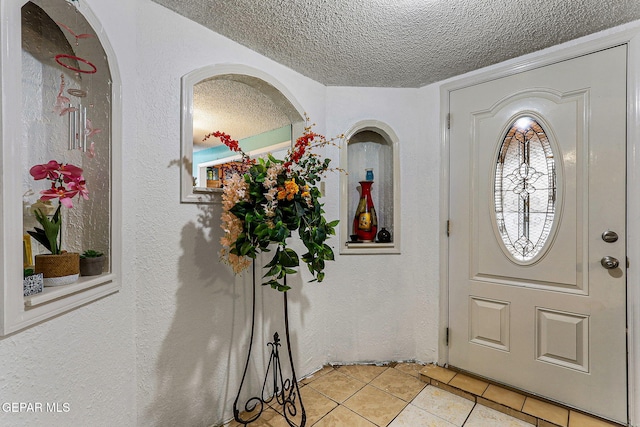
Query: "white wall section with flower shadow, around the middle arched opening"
131 0 331 426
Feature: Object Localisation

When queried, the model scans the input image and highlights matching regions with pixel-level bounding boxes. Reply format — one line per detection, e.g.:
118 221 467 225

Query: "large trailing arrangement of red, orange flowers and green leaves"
204 118 343 292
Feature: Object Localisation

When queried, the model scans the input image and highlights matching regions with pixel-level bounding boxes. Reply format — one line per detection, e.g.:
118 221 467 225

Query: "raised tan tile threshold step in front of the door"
420 364 626 427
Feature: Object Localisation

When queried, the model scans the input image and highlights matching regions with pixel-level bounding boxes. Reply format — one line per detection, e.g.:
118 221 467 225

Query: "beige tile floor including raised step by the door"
225 363 613 427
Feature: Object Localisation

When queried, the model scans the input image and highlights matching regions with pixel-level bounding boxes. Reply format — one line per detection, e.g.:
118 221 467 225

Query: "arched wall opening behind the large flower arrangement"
181 65 305 203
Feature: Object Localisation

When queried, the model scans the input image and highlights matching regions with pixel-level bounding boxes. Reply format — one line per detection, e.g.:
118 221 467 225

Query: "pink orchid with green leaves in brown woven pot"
27 160 89 286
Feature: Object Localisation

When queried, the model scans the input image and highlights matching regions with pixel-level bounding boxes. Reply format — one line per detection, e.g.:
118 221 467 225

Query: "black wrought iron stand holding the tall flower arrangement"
233 260 307 427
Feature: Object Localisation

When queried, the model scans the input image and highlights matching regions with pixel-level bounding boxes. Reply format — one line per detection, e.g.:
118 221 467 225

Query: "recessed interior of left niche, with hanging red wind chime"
21 0 112 264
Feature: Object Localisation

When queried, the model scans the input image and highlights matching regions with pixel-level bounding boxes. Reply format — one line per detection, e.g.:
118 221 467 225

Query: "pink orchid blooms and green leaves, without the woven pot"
27 160 89 255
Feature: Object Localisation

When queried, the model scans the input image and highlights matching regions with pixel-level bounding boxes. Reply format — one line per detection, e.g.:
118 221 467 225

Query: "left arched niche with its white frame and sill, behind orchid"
0 0 122 335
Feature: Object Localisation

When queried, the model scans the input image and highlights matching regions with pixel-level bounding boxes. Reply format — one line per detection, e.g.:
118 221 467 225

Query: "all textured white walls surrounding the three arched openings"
0 0 439 426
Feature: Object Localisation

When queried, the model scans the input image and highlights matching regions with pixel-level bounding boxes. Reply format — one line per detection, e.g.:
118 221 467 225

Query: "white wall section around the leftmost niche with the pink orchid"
0 0 136 427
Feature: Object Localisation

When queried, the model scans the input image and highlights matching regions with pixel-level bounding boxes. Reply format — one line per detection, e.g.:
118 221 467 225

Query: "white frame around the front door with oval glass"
438 21 640 427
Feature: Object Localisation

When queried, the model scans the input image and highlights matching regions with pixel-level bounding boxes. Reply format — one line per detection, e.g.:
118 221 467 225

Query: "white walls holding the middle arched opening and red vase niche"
136 1 438 425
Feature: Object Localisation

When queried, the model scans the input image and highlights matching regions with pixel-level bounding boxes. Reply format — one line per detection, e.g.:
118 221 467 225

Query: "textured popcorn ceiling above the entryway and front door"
153 0 640 87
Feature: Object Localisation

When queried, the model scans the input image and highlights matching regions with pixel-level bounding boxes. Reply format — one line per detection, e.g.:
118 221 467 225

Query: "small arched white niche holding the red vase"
339 120 401 255
